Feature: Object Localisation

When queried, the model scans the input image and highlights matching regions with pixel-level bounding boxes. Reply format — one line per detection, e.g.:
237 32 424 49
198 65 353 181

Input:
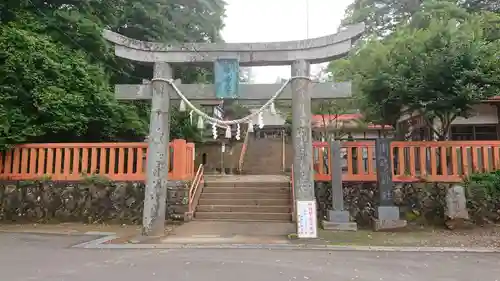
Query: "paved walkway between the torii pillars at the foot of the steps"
161 221 295 244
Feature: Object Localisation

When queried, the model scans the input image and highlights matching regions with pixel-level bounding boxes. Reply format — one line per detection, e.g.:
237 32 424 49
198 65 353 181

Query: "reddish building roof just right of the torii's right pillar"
312 113 390 130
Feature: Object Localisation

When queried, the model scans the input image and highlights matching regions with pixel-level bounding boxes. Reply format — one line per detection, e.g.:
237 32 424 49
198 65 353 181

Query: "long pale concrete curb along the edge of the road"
65 232 500 253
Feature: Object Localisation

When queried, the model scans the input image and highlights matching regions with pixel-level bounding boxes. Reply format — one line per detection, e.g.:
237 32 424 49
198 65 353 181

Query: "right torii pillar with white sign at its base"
291 60 318 238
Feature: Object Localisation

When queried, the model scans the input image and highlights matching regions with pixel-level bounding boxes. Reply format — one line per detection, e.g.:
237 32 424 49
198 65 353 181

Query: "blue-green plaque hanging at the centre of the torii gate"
214 59 240 99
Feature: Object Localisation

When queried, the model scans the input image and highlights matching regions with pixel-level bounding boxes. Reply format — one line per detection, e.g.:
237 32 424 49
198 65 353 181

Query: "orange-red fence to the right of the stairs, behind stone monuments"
313 141 500 182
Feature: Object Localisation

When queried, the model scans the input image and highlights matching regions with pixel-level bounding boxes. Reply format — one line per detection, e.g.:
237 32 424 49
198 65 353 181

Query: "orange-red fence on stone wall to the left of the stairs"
0 140 195 181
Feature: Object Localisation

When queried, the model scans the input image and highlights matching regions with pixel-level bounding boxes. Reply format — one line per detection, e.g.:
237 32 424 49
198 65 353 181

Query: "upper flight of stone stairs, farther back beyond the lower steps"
242 135 283 175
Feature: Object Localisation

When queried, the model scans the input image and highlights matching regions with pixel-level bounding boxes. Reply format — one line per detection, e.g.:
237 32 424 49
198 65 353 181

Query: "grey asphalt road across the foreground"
0 234 500 281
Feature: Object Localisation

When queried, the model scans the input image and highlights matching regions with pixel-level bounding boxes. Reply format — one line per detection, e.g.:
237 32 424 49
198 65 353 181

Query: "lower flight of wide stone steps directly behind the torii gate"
194 176 292 222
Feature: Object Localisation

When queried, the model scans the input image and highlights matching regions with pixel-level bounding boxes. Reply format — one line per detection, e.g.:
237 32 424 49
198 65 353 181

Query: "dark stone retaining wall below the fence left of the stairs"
0 179 189 224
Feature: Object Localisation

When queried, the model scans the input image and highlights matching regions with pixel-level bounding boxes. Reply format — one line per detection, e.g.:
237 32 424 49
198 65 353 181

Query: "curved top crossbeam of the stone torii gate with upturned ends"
103 23 365 66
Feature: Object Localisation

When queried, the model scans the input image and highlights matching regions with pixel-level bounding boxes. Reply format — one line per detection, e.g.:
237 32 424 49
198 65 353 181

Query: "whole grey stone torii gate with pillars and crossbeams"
103 24 364 238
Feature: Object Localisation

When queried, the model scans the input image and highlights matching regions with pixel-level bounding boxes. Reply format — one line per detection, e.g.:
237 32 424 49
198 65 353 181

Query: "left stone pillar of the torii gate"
142 62 172 236
